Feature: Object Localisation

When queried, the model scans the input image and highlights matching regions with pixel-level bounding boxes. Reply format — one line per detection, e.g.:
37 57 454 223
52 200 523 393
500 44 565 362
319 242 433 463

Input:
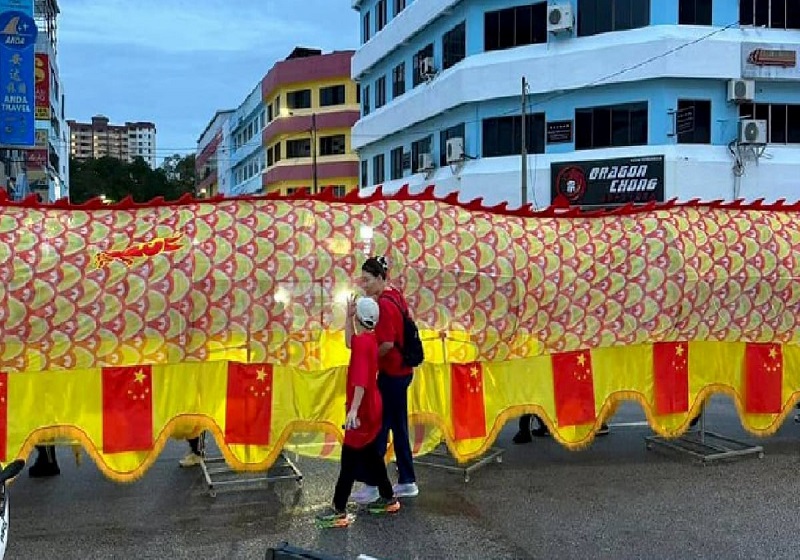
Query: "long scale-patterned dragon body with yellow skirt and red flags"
0 191 800 481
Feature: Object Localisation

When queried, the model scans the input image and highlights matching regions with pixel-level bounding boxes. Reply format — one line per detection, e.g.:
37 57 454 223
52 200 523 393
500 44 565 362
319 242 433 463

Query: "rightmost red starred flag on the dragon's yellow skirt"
744 344 783 414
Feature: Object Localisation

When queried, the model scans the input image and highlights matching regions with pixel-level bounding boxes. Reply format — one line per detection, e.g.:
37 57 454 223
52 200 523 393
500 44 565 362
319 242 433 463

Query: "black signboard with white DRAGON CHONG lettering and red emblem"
550 156 664 206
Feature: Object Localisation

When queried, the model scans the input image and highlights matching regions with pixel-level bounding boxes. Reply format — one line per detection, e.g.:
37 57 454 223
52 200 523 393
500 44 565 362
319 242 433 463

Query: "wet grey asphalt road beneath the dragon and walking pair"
7 398 800 560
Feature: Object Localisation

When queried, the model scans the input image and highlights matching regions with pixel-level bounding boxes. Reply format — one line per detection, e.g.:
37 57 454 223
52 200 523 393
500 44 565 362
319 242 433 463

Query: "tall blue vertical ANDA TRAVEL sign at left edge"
0 11 36 146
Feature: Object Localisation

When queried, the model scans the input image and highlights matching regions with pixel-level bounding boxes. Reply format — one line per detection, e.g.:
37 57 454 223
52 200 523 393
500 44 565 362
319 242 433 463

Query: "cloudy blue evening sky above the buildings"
58 0 359 163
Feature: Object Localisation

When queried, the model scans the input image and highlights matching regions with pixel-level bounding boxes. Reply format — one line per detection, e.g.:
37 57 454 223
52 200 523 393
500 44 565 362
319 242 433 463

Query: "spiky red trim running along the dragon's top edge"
0 184 800 218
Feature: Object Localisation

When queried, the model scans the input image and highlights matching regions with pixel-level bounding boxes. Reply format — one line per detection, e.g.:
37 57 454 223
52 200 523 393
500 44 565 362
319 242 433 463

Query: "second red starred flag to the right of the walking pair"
551 350 596 426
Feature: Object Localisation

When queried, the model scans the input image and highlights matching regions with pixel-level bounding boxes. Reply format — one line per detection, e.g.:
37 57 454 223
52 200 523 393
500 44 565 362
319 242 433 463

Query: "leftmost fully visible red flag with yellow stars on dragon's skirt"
102 366 153 453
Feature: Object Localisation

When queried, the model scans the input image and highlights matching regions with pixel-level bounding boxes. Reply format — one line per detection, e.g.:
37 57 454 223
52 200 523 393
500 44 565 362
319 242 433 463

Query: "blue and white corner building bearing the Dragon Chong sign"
352 0 800 207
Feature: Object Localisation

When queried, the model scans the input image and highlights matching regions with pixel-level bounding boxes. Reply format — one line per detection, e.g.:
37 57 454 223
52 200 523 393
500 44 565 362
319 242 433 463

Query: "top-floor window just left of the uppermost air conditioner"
483 2 547 51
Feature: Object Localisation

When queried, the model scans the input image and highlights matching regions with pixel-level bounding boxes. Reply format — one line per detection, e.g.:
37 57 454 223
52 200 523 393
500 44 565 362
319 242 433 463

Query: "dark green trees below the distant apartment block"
69 154 195 204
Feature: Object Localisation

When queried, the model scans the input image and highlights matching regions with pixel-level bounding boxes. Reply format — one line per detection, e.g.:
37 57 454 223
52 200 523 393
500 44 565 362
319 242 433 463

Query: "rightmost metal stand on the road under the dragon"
644 406 764 465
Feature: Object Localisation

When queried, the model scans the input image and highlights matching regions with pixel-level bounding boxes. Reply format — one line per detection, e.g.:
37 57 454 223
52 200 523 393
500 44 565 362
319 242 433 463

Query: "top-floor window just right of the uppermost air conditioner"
578 0 650 37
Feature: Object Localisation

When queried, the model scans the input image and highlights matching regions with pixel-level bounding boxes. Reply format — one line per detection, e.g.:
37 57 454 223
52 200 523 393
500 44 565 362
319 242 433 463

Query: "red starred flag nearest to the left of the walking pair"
225 362 272 445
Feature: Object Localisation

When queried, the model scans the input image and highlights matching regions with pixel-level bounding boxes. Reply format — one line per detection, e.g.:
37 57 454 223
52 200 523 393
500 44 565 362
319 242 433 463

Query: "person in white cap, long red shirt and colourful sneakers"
317 297 400 527
